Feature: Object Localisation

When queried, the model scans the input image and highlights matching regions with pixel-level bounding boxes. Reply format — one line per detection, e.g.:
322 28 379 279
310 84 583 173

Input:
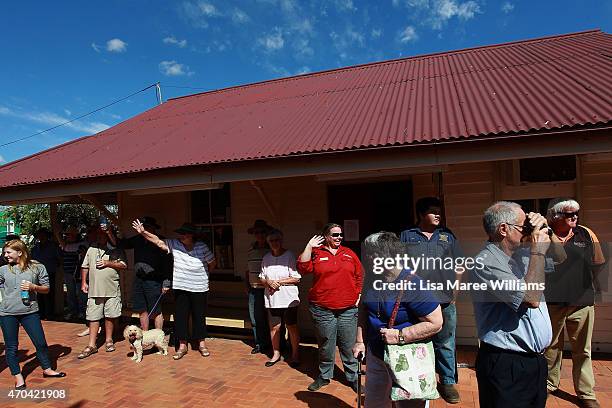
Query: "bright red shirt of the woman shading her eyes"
297 246 363 310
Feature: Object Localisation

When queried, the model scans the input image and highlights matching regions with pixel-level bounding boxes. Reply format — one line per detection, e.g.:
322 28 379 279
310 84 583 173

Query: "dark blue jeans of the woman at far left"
0 312 51 375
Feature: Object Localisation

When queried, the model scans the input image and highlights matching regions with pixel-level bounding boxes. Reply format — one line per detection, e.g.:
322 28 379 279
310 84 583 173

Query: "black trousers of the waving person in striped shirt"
174 289 208 341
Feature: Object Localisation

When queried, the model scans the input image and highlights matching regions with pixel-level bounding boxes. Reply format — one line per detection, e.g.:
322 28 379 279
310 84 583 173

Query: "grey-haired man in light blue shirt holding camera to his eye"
471 201 552 408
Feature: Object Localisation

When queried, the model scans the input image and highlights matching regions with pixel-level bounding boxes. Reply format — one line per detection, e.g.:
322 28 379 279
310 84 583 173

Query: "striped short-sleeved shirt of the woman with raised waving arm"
164 239 215 292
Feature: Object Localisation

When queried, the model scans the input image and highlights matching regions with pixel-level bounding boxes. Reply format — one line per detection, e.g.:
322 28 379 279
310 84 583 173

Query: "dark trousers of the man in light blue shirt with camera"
476 343 548 408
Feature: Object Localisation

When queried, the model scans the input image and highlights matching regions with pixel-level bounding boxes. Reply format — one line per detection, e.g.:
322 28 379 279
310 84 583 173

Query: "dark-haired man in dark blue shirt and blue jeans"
400 197 463 404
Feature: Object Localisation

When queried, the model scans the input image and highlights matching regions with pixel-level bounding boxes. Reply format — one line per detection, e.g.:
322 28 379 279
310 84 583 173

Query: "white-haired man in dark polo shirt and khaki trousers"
546 198 605 408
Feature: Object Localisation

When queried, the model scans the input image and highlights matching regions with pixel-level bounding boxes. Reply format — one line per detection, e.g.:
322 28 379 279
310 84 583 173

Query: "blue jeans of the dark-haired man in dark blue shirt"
432 303 459 384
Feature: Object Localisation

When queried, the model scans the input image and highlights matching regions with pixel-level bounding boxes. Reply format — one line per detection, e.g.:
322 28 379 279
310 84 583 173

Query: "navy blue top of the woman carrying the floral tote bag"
362 270 439 359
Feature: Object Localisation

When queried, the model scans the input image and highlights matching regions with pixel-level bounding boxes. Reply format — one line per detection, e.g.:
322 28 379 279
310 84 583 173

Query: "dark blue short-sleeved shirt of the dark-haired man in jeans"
400 226 463 303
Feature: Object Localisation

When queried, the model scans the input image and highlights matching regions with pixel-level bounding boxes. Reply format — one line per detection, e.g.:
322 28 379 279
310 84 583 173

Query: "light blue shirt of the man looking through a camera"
471 242 552 353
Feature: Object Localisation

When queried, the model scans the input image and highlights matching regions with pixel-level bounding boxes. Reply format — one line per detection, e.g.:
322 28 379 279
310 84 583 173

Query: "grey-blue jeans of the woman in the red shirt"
310 303 357 382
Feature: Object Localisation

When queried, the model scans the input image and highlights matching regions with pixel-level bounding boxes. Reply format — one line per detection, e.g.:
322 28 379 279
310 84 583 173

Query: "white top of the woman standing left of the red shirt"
259 251 302 309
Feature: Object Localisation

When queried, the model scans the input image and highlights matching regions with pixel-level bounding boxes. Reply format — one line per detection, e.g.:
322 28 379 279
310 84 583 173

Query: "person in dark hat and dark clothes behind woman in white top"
245 220 272 354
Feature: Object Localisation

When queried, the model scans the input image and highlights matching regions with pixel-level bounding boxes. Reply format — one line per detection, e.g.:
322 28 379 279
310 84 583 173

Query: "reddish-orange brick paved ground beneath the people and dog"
0 322 612 408
